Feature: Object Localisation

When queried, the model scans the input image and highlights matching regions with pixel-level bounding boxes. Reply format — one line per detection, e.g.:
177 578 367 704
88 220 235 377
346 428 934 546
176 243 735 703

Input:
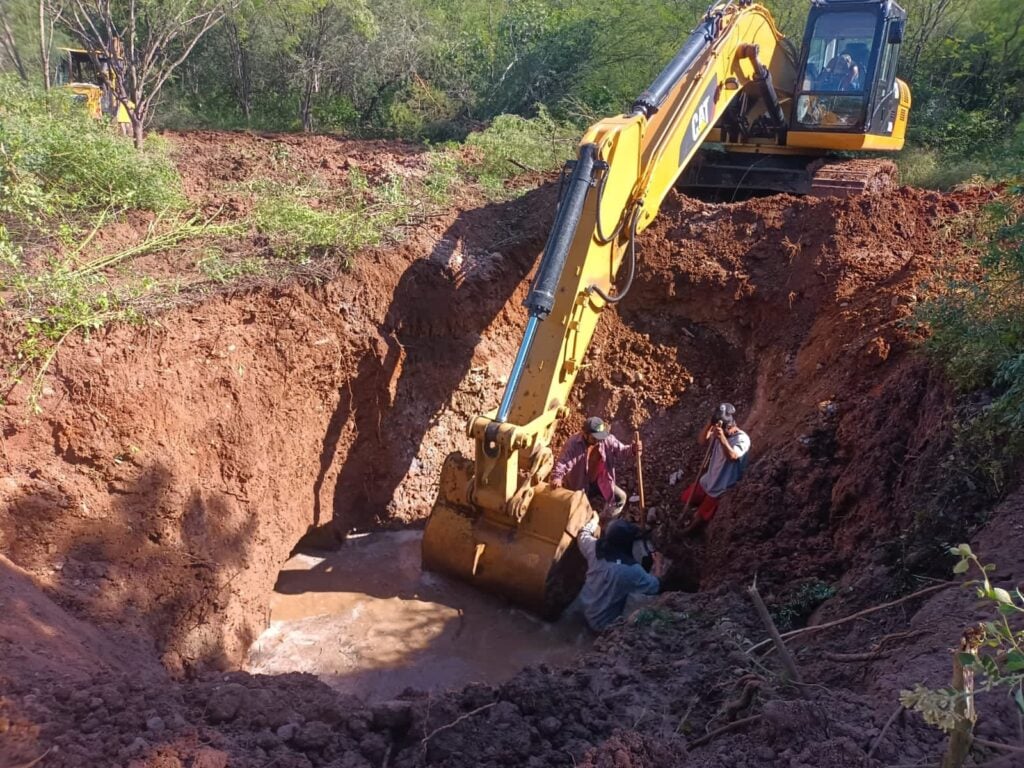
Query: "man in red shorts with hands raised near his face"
680 402 751 536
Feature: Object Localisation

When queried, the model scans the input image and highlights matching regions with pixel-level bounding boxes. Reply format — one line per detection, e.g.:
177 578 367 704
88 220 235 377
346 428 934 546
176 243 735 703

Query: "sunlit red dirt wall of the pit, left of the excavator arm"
0 191 547 671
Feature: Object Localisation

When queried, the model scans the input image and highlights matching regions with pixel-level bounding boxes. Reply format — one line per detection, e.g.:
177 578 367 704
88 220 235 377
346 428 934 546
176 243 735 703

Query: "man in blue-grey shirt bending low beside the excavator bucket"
577 512 667 632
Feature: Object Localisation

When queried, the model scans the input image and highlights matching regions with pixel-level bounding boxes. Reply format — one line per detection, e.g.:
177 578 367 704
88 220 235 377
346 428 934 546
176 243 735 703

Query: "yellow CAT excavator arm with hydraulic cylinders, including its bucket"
423 0 796 616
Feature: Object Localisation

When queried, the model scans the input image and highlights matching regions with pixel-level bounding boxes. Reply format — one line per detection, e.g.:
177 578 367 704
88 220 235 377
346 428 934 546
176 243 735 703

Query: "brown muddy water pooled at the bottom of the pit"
242 531 591 700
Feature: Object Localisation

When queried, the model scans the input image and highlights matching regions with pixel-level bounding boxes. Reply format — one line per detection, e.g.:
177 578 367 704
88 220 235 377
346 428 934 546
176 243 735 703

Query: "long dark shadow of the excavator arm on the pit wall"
312 189 546 539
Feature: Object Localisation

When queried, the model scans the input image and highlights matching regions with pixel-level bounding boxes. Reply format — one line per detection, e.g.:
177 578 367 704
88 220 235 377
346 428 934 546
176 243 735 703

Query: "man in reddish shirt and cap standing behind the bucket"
551 416 643 524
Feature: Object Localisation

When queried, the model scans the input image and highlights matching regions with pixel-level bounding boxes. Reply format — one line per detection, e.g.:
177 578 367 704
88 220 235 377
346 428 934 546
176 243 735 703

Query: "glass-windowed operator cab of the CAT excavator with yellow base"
786 0 909 150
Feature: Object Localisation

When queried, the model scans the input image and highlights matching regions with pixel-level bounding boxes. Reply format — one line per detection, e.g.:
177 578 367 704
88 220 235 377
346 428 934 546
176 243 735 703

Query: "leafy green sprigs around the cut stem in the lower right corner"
900 544 1024 732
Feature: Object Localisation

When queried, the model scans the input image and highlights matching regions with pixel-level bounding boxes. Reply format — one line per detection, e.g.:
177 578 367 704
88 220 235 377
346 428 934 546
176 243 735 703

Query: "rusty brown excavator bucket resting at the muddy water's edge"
423 453 593 621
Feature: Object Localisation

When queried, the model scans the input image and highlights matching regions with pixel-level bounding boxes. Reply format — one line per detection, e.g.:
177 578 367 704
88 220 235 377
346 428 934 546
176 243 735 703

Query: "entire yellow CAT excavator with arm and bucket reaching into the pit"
422 0 910 617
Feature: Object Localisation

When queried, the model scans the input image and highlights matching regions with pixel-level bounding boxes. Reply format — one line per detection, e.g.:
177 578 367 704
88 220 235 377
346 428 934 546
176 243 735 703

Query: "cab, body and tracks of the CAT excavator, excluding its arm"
679 0 910 200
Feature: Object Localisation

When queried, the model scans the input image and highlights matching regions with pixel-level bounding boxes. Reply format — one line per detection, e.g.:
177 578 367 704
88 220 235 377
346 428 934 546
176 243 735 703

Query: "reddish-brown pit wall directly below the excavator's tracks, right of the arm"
571 188 992 602
